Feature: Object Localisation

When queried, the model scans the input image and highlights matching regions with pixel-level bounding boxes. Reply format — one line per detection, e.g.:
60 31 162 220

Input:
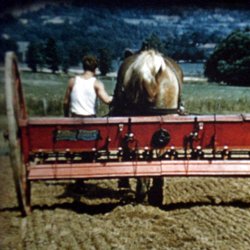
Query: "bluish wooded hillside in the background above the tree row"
0 4 250 63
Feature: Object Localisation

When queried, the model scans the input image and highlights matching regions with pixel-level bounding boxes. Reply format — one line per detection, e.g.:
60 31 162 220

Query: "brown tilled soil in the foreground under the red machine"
0 150 250 250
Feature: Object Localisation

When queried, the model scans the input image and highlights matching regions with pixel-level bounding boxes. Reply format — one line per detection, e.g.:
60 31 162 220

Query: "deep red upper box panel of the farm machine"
21 115 250 164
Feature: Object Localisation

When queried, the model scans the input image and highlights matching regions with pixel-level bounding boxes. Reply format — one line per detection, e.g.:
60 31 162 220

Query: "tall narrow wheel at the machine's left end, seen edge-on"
5 52 30 216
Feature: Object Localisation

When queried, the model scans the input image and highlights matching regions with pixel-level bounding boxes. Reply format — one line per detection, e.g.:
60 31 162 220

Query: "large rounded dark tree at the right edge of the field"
205 29 250 86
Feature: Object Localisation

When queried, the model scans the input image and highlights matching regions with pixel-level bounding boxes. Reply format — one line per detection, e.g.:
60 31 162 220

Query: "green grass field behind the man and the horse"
0 72 250 116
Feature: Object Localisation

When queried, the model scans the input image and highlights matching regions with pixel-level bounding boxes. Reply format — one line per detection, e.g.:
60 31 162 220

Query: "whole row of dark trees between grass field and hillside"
0 15 250 86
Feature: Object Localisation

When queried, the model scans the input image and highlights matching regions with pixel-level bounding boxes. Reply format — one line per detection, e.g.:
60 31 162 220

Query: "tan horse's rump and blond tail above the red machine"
109 49 183 116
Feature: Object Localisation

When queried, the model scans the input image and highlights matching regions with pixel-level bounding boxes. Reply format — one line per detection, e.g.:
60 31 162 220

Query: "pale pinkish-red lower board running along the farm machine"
28 160 250 180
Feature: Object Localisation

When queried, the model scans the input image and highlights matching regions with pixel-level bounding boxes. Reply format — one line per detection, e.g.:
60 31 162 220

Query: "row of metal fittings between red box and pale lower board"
30 146 250 164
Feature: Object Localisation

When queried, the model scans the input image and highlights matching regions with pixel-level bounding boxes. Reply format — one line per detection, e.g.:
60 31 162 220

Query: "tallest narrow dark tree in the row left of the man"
45 38 60 73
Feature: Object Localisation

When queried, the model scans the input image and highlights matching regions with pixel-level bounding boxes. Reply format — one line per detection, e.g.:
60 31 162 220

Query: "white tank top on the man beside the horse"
70 76 96 116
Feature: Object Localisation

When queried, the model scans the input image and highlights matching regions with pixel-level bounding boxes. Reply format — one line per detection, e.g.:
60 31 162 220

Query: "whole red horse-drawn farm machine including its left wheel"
5 52 250 215
